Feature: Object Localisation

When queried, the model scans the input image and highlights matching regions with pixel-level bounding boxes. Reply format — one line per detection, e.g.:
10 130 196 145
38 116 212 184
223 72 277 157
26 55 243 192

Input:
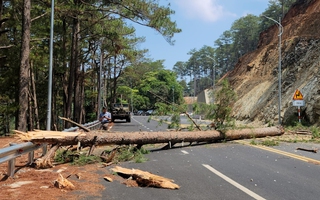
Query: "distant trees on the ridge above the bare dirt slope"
173 0 295 96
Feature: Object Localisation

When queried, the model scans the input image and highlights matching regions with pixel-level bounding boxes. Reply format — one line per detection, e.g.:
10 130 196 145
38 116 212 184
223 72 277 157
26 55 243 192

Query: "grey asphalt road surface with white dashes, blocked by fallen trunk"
88 116 320 200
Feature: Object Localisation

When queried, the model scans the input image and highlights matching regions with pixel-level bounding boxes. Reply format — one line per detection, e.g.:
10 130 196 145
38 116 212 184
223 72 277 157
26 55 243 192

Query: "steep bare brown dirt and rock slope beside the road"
229 0 320 124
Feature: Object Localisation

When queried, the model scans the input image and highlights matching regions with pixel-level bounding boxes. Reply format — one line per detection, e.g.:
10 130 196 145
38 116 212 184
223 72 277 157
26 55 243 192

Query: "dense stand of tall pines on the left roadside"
0 0 181 134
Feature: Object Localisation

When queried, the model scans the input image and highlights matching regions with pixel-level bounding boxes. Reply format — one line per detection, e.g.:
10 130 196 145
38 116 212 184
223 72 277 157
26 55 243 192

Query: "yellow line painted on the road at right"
237 141 320 165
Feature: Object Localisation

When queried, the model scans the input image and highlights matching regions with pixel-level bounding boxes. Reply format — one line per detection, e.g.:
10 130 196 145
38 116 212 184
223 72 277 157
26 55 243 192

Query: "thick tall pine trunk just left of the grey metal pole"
18 0 31 131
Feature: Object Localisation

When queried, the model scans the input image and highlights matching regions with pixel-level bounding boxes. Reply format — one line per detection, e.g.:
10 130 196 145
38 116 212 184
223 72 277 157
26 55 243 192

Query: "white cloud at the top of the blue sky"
175 0 228 21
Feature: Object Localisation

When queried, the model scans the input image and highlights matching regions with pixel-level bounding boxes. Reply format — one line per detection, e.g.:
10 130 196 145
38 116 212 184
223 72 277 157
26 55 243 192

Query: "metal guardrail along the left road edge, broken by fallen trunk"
0 121 101 177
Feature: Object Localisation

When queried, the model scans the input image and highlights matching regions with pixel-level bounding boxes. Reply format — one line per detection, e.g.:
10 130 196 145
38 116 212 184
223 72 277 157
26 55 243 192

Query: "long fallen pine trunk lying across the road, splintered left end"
16 127 284 146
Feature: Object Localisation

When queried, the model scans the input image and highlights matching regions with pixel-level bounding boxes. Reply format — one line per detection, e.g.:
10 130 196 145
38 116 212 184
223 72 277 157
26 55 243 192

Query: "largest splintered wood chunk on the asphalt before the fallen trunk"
111 166 180 190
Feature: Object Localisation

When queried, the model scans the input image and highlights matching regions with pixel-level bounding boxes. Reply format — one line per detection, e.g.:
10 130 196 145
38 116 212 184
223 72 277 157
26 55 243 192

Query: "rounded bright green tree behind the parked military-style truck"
116 60 183 113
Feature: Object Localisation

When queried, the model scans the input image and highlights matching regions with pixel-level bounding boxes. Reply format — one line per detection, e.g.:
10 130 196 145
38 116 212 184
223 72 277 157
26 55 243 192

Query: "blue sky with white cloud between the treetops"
135 0 269 69
